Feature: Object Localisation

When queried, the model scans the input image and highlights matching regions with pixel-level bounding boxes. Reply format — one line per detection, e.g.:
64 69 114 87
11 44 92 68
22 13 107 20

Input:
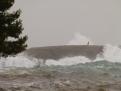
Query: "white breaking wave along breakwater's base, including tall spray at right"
0 44 121 69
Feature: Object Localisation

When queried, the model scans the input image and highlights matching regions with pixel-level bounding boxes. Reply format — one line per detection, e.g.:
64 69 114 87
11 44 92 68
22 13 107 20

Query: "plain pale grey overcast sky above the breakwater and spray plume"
13 0 121 47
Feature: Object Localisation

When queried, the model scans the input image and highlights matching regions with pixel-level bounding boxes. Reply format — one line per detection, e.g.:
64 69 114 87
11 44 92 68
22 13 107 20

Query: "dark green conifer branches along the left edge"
0 0 27 57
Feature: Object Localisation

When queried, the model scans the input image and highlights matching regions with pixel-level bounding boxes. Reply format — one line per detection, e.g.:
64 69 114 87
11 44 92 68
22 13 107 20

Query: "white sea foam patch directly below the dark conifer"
0 56 37 69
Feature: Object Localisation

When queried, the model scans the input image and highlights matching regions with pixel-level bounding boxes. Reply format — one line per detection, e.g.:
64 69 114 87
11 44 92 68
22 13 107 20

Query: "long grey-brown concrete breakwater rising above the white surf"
24 45 103 60
